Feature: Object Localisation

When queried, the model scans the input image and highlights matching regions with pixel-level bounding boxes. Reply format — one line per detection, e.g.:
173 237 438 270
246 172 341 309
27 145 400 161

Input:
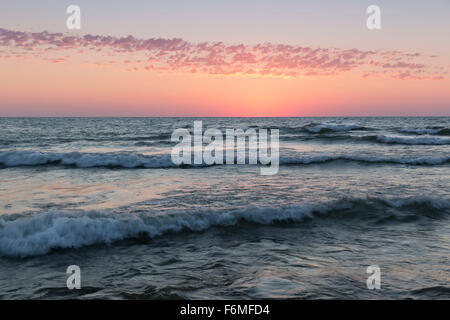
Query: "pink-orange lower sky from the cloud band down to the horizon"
0 0 450 116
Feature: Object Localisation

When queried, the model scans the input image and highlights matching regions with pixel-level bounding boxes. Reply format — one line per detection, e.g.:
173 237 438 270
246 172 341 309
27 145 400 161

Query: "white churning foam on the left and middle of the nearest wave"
0 206 320 257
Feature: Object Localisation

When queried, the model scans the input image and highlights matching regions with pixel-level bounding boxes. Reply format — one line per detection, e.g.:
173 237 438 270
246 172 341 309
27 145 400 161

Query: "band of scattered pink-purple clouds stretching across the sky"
0 28 446 80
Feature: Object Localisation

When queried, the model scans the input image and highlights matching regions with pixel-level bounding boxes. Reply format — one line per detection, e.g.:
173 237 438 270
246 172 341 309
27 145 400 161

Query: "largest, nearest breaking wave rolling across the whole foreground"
0 198 450 258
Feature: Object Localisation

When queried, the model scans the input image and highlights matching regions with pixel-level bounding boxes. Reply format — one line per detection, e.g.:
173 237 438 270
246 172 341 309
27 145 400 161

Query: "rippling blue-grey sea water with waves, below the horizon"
0 117 450 299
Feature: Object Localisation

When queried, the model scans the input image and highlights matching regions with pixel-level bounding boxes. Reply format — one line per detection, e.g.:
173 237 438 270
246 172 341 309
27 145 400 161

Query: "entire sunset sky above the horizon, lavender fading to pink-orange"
0 0 450 117
